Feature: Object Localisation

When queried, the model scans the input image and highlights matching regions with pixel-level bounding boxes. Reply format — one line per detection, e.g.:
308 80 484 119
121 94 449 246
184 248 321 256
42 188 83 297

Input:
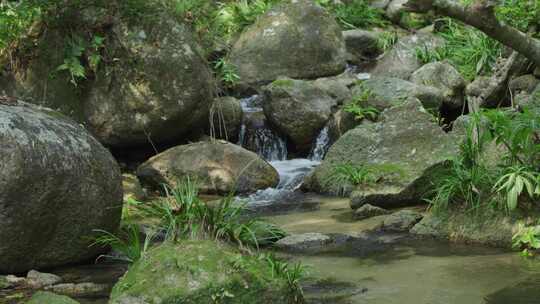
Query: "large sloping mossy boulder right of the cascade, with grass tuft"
311 99 460 209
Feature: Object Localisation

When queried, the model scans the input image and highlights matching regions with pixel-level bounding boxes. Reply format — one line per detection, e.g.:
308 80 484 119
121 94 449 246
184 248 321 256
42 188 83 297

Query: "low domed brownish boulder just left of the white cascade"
137 141 279 194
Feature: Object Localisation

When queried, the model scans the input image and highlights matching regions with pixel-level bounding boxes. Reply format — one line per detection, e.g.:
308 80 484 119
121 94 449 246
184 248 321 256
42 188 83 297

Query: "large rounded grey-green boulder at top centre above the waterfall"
229 0 346 86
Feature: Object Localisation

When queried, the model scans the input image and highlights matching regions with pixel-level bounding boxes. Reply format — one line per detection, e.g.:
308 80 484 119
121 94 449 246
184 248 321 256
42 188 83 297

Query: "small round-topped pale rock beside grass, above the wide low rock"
411 62 467 109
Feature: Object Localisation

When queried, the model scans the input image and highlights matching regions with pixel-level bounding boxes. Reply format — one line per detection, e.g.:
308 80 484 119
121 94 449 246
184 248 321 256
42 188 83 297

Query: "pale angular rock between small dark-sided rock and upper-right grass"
372 33 444 80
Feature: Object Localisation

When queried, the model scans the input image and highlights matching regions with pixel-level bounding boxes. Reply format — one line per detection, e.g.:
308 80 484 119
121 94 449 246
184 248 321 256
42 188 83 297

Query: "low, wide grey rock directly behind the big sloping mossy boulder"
353 77 452 113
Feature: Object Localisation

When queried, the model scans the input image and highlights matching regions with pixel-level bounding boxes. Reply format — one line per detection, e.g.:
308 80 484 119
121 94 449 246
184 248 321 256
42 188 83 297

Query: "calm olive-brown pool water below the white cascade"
268 197 540 304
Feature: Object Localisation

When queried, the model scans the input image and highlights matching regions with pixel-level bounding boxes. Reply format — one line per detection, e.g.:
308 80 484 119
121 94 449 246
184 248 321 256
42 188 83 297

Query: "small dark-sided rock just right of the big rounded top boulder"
343 29 383 63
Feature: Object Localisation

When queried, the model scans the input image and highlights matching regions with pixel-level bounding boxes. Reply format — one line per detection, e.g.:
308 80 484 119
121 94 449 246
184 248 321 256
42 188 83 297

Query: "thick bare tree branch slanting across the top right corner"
405 0 540 67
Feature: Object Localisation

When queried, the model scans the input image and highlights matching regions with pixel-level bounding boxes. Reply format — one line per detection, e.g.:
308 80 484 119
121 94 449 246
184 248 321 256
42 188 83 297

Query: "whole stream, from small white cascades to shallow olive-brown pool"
4 107 540 304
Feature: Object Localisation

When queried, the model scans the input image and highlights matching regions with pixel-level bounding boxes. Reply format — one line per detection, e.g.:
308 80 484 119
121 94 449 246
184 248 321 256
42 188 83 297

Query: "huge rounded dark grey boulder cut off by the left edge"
0 101 122 273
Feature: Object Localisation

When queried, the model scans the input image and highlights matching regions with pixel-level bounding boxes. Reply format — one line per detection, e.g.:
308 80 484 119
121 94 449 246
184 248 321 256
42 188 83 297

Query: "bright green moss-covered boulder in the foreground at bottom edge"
109 240 301 304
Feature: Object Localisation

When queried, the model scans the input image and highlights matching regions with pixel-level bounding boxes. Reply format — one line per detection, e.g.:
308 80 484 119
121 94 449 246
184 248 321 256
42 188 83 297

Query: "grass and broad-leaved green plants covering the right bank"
430 109 540 214
